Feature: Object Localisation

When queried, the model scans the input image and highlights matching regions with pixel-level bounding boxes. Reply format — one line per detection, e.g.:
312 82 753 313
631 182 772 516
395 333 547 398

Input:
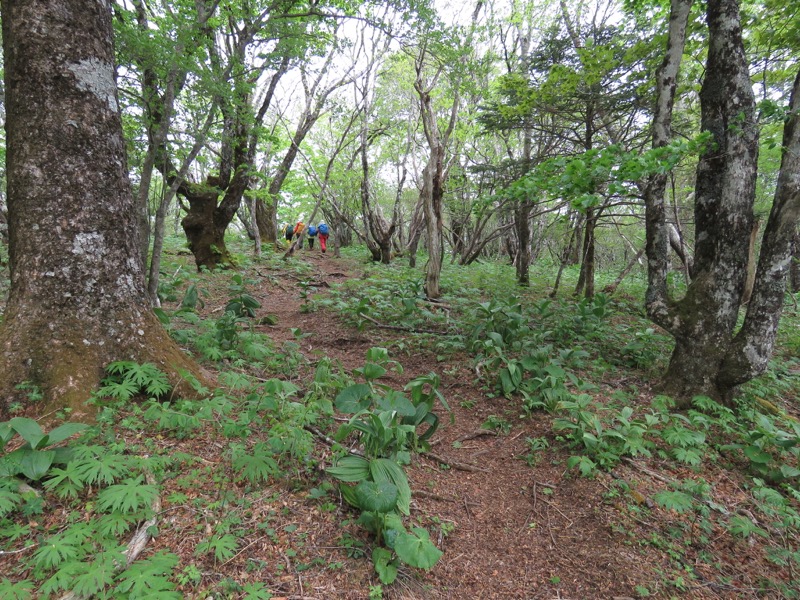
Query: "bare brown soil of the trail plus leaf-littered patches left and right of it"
0 249 790 600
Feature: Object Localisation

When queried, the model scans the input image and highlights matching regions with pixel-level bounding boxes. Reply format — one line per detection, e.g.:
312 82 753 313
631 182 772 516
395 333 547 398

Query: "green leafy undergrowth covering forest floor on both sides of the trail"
0 238 800 599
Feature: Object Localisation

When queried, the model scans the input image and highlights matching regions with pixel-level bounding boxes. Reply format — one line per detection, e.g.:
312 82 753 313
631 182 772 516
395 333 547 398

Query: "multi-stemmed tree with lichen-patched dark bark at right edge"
645 0 800 406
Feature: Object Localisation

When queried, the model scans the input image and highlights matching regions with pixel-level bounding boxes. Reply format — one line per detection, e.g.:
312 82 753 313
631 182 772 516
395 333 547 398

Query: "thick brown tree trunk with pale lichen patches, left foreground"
0 0 209 418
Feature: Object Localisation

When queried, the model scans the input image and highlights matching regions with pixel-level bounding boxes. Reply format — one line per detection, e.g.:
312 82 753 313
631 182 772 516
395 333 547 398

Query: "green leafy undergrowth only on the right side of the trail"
308 247 800 598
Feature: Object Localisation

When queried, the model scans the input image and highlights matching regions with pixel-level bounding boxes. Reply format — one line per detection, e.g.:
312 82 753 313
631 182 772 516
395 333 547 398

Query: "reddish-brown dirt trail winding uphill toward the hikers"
250 250 654 599
